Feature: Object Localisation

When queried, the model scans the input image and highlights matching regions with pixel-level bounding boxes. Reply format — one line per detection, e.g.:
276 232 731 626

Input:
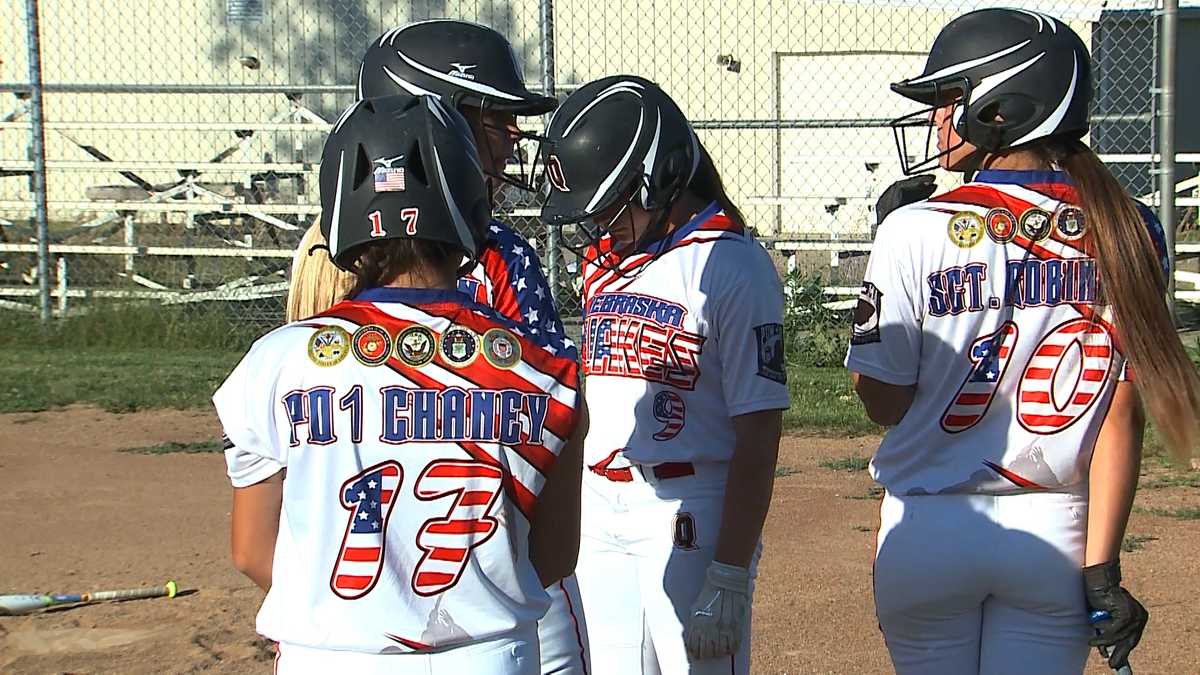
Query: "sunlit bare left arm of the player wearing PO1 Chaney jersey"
229 471 283 591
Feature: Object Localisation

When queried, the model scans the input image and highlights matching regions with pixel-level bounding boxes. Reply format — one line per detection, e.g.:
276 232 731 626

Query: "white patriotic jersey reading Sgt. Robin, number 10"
846 171 1165 495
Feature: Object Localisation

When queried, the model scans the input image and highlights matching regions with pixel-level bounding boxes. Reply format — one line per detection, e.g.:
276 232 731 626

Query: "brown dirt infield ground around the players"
0 408 1200 675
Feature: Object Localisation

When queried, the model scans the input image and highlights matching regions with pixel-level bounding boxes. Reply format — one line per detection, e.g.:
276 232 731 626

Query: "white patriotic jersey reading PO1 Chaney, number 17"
214 288 578 653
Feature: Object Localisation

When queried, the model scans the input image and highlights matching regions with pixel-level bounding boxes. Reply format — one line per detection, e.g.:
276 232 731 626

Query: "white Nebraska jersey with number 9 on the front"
583 203 788 466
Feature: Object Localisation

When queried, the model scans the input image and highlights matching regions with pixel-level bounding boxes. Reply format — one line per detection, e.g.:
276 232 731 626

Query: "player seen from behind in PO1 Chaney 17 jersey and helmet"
214 91 586 675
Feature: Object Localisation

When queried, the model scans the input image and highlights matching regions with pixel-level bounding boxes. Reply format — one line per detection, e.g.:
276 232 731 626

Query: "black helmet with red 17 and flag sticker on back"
320 95 491 271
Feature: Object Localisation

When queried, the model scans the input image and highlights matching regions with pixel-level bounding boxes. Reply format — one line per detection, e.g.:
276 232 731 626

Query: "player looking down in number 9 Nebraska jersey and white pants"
542 76 788 675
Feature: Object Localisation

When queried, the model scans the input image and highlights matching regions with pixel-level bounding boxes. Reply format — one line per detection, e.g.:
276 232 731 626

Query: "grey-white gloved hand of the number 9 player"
684 561 750 661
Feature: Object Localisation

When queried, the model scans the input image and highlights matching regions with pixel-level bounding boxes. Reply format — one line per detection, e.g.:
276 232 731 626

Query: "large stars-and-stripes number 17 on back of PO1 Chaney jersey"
329 460 504 599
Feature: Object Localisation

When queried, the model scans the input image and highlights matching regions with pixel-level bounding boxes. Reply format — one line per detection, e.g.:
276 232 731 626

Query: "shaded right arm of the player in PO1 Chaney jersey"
529 393 589 587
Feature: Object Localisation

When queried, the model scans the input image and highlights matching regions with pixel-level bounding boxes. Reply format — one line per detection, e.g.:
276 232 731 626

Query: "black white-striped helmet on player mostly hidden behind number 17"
358 19 558 115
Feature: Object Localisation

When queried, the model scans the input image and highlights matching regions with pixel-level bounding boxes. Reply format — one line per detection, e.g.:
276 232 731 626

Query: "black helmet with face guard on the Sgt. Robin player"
892 8 1092 173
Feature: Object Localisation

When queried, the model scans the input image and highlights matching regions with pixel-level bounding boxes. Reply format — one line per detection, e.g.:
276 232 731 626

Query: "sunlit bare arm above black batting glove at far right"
1084 382 1146 566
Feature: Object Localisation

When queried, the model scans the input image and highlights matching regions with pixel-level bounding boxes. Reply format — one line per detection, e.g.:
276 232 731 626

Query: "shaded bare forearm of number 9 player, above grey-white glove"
714 410 784 568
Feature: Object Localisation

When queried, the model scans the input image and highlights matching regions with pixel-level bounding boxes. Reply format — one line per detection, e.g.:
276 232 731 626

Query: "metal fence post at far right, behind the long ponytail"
1158 0 1180 318
